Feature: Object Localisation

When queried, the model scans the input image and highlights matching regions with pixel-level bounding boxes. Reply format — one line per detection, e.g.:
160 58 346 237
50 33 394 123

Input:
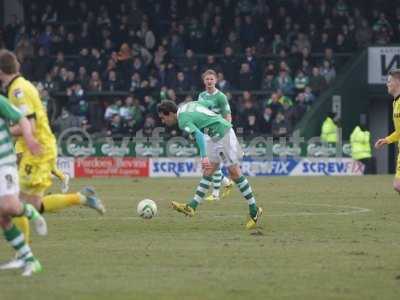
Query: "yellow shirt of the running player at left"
7 76 57 157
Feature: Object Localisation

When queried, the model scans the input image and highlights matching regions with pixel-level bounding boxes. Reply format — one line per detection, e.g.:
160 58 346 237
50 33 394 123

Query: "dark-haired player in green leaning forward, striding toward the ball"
158 100 262 229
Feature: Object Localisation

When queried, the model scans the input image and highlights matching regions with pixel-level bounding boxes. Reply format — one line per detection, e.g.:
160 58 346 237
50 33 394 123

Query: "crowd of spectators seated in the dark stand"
0 0 400 137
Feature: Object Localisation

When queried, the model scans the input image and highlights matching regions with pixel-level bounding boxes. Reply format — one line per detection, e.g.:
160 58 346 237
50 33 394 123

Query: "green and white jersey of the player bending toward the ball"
177 101 232 139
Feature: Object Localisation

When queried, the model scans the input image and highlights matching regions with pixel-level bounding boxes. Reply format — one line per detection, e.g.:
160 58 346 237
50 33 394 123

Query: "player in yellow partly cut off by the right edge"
375 69 400 193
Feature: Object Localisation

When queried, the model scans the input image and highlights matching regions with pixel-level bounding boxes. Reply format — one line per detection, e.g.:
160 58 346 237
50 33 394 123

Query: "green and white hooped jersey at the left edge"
0 96 22 166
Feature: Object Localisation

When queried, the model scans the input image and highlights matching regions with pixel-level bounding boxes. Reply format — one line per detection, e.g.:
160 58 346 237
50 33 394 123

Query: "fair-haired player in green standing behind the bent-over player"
198 69 233 201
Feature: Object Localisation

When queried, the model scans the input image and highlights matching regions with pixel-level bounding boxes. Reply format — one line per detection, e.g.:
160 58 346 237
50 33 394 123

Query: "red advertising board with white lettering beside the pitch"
75 156 149 177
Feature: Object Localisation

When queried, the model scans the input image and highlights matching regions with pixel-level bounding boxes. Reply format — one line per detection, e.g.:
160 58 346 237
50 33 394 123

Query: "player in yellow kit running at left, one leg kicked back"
0 50 105 266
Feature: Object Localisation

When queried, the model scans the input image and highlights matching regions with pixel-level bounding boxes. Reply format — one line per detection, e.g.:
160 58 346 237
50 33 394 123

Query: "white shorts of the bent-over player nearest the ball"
205 128 243 167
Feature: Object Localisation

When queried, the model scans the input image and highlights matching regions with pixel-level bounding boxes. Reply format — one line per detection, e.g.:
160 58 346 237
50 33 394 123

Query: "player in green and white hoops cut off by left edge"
0 96 47 276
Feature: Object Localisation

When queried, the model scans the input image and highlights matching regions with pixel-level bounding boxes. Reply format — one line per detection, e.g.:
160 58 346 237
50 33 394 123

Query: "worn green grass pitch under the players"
0 176 400 300
